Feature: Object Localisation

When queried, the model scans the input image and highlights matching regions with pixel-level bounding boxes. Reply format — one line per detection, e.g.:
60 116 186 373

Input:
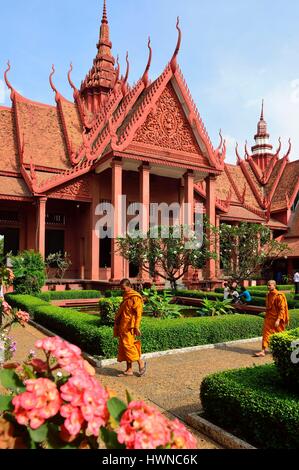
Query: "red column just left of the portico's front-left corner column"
90 175 100 281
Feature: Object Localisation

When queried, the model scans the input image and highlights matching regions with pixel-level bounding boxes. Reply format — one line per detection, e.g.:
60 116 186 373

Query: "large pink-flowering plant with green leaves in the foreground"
0 337 196 449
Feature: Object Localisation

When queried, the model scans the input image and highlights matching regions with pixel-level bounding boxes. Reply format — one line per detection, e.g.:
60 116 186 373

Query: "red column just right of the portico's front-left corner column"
139 164 150 282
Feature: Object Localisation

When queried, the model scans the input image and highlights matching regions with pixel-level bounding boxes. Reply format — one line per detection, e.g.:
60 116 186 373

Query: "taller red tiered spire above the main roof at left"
80 0 116 113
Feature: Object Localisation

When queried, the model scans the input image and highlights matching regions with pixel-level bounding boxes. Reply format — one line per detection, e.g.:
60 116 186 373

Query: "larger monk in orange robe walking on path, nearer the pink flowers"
114 279 146 377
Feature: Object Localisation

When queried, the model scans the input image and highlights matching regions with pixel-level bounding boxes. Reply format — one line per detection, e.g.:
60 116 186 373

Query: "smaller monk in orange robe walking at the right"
254 281 290 357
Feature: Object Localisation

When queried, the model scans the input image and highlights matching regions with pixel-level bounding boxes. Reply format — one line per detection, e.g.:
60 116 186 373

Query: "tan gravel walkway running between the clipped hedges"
9 326 272 449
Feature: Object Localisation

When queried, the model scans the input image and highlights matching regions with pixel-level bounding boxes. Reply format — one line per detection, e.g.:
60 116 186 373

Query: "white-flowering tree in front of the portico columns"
118 224 217 289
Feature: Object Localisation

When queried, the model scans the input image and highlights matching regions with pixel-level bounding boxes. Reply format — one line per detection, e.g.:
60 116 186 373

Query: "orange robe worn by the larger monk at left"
114 290 143 362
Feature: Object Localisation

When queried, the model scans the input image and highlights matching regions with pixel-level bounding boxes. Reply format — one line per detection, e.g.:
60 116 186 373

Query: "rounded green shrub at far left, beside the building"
11 250 46 295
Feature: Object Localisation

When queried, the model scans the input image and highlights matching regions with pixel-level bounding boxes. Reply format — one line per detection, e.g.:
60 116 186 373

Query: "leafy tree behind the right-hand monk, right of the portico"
219 222 289 281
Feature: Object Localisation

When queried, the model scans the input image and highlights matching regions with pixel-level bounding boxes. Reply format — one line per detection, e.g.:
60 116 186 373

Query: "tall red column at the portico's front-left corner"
111 160 125 282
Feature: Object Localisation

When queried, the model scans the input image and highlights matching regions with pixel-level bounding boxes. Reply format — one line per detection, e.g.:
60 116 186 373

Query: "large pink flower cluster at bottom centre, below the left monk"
117 401 171 449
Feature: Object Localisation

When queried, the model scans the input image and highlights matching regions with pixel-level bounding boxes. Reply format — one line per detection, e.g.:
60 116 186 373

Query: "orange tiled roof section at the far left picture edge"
0 107 20 172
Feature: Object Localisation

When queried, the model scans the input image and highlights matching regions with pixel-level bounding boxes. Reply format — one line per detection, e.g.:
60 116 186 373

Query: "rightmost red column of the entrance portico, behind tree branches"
206 175 216 279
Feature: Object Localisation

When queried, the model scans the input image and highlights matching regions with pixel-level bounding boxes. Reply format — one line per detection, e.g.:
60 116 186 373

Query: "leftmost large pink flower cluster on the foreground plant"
12 378 61 429
